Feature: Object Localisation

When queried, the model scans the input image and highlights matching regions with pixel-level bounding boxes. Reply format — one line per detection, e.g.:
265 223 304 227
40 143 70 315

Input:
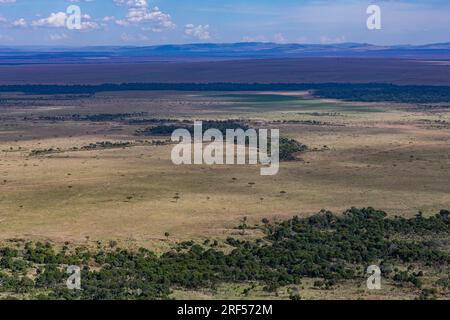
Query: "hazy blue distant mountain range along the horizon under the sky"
0 42 450 65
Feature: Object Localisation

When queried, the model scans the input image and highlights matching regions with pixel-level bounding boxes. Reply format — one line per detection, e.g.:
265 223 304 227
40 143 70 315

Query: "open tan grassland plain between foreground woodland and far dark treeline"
0 92 450 250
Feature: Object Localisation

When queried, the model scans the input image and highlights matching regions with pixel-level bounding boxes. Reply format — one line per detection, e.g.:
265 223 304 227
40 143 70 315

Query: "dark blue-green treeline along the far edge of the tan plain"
0 83 450 103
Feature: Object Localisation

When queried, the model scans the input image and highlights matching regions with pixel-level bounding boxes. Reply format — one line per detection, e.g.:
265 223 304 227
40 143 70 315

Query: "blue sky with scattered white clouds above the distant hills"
0 0 450 46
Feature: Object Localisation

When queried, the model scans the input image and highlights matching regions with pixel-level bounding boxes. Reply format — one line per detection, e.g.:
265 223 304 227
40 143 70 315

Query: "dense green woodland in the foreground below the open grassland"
0 208 450 299
